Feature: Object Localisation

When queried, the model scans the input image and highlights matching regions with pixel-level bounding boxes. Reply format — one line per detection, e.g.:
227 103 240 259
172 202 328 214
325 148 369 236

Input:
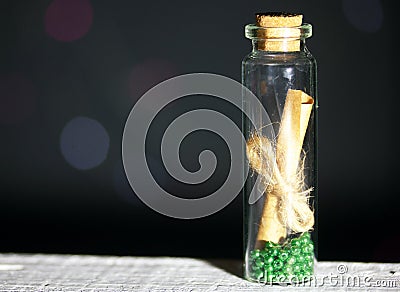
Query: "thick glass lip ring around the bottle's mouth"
245 23 312 40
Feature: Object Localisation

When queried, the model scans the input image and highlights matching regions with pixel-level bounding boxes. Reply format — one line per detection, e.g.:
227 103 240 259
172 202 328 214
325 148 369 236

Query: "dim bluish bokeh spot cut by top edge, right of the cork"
342 0 383 32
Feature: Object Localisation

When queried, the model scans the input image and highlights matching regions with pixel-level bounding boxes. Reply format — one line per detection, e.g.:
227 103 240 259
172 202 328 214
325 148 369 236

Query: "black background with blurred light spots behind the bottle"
0 0 400 262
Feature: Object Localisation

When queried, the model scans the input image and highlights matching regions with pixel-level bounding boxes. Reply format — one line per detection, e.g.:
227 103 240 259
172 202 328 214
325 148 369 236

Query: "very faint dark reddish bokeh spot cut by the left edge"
0 73 36 124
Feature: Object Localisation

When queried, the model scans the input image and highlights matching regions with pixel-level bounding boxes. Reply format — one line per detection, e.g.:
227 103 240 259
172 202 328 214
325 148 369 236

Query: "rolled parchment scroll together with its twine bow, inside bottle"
247 89 314 245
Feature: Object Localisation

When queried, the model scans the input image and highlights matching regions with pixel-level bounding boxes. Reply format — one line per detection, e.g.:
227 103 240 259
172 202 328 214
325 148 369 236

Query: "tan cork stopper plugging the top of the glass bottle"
256 12 303 52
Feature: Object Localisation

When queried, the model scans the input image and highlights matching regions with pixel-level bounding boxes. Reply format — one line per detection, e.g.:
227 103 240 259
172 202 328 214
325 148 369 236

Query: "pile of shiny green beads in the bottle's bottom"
250 232 314 283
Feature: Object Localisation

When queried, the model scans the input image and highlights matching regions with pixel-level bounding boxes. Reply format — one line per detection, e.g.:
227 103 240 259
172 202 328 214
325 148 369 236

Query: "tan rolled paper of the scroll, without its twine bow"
257 89 314 245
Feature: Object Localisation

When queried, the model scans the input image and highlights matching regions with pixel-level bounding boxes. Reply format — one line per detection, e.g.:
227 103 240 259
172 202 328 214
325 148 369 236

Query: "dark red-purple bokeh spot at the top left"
45 0 93 42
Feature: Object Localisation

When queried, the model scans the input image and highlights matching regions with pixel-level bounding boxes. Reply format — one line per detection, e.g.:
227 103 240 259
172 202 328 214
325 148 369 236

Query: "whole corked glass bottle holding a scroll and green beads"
242 13 318 283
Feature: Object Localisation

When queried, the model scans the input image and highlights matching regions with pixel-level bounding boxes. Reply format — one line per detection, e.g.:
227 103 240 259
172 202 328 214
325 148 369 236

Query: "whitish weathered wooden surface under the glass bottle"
0 254 400 291
